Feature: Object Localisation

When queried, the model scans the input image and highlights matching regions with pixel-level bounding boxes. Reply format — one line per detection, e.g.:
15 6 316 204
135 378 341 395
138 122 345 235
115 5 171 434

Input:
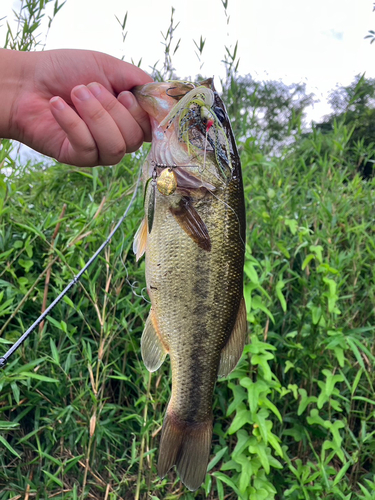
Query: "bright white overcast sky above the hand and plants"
0 0 375 123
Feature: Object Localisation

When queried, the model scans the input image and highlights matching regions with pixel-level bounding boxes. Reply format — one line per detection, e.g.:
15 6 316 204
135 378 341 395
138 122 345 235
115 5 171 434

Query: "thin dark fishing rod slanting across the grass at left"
0 169 142 368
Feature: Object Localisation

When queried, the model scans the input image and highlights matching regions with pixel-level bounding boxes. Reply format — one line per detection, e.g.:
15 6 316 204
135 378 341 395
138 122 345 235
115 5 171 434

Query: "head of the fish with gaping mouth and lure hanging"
132 78 240 185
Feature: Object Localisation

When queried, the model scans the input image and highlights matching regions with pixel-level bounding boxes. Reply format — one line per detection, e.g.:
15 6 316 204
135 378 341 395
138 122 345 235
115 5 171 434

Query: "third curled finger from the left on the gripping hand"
87 82 148 153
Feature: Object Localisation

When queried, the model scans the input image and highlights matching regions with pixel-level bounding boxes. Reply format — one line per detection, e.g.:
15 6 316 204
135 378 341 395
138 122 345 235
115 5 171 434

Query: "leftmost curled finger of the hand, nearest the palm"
50 96 98 167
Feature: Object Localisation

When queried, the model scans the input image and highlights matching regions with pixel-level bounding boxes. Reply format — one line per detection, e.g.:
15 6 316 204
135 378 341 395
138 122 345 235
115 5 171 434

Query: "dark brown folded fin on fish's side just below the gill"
170 196 211 252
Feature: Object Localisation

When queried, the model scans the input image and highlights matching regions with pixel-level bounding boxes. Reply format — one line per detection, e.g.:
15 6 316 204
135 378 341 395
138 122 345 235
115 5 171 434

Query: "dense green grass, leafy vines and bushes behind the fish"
0 0 375 500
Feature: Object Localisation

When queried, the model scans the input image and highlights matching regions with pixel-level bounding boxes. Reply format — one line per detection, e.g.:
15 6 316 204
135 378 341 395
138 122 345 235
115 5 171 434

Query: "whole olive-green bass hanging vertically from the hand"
133 79 247 491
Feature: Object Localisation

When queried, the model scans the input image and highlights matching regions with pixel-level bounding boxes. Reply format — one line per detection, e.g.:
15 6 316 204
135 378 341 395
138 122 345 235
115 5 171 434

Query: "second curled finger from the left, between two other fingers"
71 84 128 165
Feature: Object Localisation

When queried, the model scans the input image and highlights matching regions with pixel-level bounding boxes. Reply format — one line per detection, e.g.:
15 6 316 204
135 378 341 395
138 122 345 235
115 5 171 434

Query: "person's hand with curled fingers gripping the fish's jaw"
0 50 152 166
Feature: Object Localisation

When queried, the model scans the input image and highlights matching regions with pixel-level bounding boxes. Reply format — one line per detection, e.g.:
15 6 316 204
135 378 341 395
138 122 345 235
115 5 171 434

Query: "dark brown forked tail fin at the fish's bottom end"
158 412 212 491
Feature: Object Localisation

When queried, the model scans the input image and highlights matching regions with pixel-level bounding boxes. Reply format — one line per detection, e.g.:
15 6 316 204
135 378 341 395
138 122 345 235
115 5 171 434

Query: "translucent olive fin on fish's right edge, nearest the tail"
218 297 247 377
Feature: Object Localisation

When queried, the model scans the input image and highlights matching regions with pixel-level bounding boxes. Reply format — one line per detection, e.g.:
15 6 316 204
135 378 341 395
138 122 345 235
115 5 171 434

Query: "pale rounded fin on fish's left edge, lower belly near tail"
141 309 167 372
